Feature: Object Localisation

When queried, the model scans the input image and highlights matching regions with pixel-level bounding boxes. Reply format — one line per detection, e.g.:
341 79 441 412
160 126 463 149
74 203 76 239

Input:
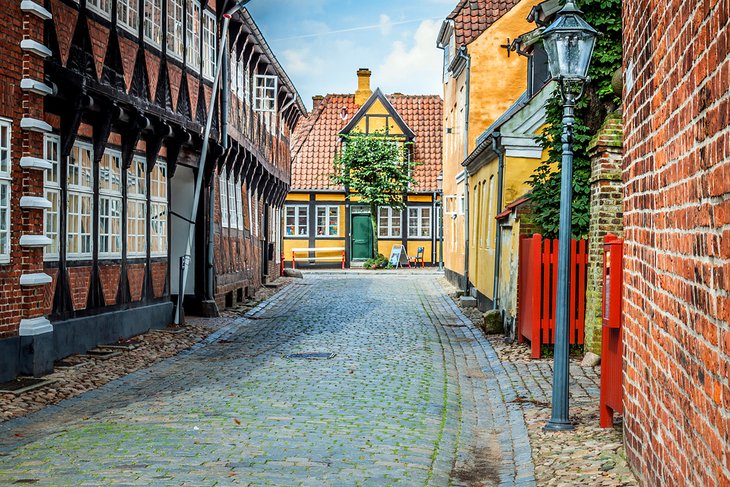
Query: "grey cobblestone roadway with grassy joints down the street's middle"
0 272 534 486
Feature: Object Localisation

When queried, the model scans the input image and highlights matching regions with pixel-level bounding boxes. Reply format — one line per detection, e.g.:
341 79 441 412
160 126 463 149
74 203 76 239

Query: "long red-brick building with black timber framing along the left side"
0 0 305 380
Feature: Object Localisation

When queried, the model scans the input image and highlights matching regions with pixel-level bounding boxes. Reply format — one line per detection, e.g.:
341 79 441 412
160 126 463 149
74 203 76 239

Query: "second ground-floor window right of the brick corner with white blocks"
66 142 94 259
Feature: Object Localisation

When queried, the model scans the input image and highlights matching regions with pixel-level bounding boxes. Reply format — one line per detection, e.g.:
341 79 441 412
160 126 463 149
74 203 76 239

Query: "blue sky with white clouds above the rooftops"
248 0 458 107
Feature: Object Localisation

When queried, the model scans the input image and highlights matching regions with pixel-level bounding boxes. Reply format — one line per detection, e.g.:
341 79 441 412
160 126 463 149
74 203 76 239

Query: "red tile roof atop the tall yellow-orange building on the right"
447 0 520 47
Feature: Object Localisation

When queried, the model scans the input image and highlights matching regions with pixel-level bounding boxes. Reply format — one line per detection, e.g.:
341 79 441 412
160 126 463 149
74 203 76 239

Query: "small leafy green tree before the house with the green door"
330 132 417 256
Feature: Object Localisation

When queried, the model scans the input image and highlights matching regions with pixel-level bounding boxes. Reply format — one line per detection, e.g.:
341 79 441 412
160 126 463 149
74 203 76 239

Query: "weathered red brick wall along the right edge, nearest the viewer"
623 0 730 486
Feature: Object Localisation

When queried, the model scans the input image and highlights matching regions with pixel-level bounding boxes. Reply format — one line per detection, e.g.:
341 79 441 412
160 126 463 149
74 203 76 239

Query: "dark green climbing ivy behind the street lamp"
528 0 622 238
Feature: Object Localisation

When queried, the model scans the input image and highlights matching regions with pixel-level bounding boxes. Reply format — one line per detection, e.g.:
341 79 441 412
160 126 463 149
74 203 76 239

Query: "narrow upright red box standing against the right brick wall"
600 235 623 428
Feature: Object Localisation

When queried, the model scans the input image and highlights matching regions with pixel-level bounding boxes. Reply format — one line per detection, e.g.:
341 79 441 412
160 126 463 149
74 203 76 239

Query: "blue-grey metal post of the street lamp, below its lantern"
545 86 577 431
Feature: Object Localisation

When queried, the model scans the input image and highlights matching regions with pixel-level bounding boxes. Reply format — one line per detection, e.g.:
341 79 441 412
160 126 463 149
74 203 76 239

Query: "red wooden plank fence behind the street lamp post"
517 234 588 358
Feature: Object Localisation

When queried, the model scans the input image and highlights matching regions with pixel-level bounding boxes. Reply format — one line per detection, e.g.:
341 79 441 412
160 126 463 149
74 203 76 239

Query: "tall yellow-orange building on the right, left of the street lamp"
438 0 557 310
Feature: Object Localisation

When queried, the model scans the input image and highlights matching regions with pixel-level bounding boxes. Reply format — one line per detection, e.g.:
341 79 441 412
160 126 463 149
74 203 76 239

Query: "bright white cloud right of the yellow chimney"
373 20 443 95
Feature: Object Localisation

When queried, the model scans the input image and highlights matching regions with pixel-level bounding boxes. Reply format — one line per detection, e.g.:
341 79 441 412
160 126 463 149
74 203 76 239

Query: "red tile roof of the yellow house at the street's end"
291 94 443 192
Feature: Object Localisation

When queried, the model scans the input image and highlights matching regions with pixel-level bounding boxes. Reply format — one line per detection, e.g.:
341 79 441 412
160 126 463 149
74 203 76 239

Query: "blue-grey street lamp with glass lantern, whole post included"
542 0 598 431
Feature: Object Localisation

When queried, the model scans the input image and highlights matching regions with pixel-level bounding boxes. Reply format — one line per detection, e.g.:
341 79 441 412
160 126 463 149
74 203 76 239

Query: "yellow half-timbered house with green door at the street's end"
284 69 442 267
